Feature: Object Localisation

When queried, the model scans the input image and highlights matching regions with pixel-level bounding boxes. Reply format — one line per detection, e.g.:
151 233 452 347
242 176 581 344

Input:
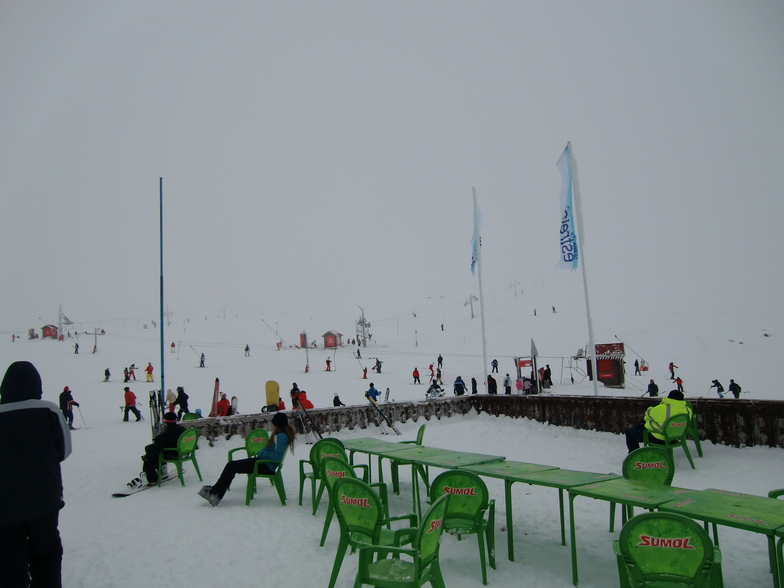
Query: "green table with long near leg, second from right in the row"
569 478 693 586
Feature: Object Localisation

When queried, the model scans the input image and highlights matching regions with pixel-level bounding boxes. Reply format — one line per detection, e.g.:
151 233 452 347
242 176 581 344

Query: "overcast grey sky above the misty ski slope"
0 0 784 330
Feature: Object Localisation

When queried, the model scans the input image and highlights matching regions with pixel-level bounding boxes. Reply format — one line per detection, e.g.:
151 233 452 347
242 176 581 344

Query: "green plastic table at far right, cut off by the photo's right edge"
659 488 784 588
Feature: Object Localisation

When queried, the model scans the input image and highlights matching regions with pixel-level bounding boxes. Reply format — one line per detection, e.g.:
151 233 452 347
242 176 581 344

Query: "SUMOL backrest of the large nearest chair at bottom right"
618 512 714 586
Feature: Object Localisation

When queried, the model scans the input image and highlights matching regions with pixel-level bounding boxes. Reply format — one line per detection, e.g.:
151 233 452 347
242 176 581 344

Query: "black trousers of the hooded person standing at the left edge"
0 511 63 588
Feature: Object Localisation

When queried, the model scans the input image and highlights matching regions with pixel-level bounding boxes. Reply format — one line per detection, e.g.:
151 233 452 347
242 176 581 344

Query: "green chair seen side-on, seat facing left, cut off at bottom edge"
354 494 454 588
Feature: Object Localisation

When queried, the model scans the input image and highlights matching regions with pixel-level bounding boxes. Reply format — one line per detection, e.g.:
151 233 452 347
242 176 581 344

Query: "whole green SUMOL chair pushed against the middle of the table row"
429 470 495 586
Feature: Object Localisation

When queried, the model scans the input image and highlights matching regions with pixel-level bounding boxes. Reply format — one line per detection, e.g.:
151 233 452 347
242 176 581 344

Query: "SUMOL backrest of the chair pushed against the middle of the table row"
430 470 490 533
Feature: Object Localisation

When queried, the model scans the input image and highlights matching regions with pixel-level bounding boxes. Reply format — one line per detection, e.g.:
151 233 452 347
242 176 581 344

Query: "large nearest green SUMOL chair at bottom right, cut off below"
613 512 723 588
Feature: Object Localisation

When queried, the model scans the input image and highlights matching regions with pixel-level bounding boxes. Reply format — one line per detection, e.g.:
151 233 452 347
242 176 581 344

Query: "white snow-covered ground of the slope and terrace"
0 304 784 588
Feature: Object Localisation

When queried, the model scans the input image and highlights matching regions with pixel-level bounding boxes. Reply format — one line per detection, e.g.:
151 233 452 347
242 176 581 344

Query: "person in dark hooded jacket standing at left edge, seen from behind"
0 361 71 588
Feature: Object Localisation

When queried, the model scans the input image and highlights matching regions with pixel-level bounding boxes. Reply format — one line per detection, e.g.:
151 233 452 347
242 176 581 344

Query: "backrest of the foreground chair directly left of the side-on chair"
330 478 384 544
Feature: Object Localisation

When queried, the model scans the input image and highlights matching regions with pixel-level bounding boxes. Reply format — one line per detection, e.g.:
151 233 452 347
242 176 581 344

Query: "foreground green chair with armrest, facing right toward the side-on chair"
329 478 418 588
